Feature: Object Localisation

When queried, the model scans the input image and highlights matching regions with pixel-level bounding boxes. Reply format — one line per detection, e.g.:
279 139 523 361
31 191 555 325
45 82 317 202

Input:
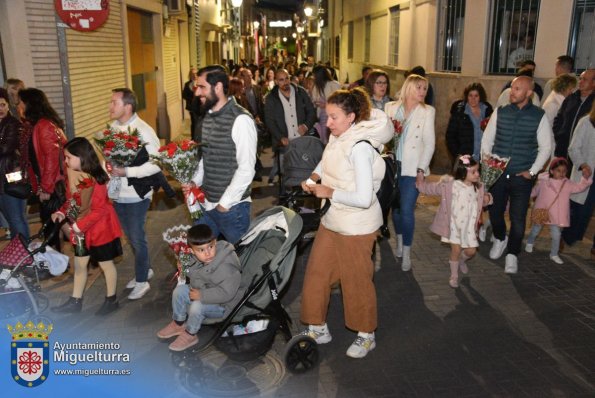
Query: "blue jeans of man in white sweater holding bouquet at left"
114 199 151 282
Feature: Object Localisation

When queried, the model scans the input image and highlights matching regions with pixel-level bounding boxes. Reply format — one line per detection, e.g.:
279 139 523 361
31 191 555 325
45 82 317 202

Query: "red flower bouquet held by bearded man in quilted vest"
151 140 205 219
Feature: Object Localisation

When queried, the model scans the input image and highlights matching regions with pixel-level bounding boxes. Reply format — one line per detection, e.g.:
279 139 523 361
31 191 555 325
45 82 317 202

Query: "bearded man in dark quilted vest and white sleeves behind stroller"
183 65 257 244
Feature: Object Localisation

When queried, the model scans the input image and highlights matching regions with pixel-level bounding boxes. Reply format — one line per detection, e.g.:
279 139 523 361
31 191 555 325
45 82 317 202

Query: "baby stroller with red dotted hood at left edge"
0 222 68 318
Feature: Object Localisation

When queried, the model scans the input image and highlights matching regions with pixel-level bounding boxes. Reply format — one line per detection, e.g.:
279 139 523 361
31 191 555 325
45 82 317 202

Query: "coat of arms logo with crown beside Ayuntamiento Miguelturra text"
8 321 54 387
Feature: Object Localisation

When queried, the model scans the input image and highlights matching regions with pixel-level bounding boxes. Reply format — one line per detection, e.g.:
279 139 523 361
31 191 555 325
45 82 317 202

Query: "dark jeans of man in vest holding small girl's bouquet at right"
489 174 533 256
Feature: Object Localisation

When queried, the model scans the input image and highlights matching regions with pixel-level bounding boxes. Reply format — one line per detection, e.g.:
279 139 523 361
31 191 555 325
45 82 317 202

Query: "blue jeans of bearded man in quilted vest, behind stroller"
194 202 251 244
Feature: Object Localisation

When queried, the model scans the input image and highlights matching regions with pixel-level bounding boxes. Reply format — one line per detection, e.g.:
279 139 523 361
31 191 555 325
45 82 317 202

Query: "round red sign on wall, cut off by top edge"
54 0 109 32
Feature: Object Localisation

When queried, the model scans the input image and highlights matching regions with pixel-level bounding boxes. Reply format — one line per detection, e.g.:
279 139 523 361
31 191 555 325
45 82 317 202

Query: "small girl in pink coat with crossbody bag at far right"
525 158 593 264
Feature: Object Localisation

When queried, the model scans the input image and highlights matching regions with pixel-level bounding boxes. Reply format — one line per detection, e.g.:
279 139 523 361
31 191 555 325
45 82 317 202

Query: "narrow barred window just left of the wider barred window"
436 0 465 72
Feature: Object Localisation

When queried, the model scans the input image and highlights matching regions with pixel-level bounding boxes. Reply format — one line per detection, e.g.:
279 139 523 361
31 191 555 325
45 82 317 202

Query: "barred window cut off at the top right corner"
568 0 595 73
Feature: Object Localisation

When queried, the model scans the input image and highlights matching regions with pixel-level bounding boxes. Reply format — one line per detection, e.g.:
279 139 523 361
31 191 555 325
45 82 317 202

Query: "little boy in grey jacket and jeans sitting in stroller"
157 225 244 351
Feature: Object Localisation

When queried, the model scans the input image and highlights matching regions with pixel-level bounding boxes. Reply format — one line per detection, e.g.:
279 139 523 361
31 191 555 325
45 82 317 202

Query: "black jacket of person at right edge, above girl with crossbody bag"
552 91 595 157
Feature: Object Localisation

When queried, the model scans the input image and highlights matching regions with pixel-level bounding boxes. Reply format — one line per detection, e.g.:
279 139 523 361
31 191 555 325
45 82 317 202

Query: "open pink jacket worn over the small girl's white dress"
417 176 492 238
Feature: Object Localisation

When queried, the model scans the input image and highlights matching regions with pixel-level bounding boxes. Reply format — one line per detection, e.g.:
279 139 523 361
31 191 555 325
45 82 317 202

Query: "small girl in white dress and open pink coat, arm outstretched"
416 155 492 288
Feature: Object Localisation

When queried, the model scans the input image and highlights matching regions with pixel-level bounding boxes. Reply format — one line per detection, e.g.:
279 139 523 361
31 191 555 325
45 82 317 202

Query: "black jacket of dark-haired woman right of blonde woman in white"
446 100 493 156
